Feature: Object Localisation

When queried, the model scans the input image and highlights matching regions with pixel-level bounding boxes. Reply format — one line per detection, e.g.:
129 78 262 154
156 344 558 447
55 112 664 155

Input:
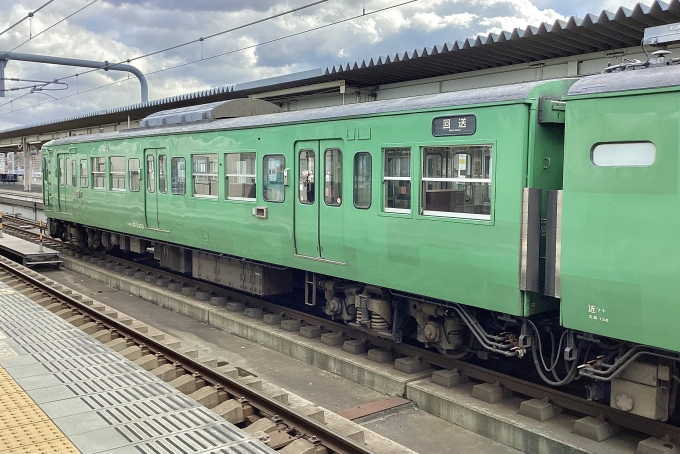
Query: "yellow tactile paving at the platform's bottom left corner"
0 367 80 454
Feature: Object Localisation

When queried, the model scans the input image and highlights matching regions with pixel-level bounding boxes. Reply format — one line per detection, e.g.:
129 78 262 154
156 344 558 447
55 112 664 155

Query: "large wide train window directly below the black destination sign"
421 145 492 219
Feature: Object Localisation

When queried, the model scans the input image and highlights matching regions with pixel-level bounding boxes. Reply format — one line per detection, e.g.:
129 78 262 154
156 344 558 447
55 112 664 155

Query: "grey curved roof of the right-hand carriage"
567 65 680 96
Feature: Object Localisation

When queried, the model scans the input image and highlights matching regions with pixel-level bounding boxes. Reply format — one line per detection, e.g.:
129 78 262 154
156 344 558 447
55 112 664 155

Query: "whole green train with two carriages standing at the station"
42 60 680 420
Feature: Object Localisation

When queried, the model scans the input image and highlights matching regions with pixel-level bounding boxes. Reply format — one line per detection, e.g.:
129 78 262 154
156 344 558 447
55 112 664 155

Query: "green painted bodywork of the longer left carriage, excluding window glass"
46 80 571 315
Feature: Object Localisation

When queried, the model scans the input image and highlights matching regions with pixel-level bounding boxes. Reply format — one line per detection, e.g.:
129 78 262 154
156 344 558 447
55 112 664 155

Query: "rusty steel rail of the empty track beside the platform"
0 262 374 454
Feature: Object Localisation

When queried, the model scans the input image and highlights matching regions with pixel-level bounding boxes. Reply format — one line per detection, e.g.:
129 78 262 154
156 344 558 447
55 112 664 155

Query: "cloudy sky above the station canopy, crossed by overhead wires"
0 0 651 130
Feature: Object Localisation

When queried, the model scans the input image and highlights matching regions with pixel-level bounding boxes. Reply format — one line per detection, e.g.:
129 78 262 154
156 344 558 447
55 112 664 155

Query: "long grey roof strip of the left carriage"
44 81 546 146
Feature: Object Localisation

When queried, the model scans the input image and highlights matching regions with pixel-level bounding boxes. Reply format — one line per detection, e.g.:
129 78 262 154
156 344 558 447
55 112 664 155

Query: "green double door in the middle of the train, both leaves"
294 140 344 262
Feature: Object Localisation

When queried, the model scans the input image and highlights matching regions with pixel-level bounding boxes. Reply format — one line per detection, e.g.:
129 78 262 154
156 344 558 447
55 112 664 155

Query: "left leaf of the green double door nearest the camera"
294 140 321 258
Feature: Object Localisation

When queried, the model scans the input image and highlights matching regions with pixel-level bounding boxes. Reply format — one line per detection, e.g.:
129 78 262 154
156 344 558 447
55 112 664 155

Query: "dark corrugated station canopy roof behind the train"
0 0 680 139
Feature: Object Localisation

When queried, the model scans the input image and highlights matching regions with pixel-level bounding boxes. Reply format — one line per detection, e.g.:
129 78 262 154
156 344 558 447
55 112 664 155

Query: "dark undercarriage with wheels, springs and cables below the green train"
49 220 680 423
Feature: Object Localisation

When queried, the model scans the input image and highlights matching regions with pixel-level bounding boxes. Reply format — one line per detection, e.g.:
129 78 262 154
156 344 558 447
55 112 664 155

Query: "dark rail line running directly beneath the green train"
5 217 680 443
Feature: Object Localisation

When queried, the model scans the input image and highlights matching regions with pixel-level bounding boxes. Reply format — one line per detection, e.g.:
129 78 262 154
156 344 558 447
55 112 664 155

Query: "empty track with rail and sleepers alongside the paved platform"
0 231 373 454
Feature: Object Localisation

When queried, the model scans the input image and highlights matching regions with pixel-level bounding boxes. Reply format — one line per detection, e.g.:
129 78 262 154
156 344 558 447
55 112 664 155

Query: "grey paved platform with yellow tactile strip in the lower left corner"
0 274 275 454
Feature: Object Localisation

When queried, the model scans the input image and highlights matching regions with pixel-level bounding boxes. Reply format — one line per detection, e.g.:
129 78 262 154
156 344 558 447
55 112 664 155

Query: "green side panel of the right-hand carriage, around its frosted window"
561 90 680 351
